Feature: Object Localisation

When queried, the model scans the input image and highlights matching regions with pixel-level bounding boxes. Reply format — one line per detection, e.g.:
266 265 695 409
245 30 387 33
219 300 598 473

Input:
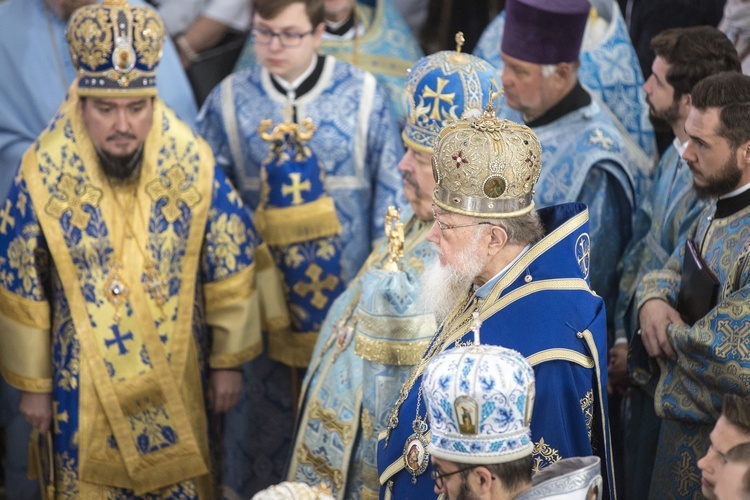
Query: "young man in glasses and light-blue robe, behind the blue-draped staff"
198 0 405 494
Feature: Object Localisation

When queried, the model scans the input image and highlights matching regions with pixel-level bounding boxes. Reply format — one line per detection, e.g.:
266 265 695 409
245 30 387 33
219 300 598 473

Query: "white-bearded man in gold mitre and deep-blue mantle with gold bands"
377 107 614 499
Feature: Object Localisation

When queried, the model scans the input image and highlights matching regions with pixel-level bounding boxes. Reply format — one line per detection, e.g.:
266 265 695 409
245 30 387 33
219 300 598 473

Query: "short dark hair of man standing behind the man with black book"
651 26 742 101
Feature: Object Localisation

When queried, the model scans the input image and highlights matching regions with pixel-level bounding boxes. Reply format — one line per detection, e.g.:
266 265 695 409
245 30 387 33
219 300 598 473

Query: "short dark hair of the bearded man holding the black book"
691 71 750 149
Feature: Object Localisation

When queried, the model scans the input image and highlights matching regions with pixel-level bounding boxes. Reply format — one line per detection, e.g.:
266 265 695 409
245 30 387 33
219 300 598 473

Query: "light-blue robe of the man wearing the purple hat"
533 102 647 337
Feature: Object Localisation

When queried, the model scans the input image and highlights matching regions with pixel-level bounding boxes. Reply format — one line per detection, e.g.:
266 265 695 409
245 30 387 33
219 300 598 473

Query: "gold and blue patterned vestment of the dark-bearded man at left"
0 89 261 498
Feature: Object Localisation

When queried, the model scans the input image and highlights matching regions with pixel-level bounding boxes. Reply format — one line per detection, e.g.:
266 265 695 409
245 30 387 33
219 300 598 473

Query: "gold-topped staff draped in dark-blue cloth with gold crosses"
255 110 344 367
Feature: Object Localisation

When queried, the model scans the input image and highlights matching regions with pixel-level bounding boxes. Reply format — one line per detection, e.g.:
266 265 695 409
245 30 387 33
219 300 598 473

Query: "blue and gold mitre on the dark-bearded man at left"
67 0 166 97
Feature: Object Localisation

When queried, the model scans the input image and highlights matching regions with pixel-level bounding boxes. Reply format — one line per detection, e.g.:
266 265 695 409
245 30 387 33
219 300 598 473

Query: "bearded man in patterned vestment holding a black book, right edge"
636 73 750 498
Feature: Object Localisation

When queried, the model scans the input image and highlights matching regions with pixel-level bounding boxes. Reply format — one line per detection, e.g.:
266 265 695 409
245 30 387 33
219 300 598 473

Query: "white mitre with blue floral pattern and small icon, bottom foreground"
422 345 535 464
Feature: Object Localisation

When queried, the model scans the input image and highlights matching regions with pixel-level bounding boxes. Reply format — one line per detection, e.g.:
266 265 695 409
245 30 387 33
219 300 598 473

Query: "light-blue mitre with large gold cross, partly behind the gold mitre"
402 33 501 154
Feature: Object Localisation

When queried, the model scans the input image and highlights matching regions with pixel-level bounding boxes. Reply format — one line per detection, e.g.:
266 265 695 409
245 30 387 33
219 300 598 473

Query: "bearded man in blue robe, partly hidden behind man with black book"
608 26 740 499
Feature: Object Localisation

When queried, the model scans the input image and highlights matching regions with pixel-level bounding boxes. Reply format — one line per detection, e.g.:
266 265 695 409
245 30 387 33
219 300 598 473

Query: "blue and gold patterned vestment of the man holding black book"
636 197 750 499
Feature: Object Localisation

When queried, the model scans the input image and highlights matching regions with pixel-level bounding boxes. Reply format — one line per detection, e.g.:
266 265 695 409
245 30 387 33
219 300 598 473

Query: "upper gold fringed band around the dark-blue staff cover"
255 196 341 246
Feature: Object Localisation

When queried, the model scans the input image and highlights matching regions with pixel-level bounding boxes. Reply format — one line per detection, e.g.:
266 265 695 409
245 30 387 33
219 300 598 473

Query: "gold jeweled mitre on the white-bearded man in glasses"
432 104 542 219
